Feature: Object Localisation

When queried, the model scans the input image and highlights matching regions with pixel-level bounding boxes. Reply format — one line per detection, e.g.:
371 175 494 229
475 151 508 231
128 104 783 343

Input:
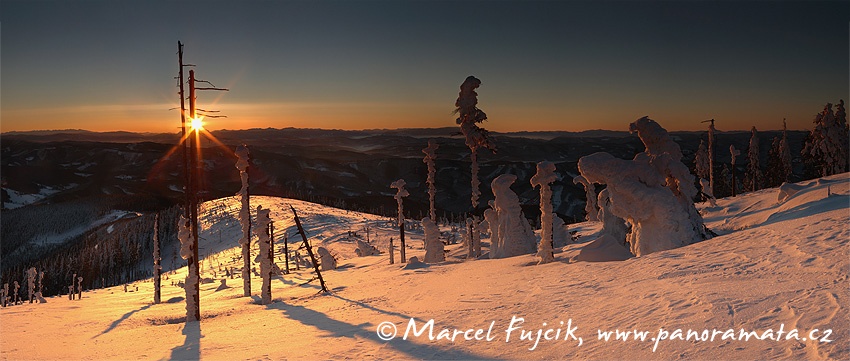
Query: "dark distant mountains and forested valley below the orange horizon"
0 127 806 222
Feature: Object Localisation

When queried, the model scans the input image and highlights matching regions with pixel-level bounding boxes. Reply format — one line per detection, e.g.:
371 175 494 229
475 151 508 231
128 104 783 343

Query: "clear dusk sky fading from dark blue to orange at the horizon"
0 0 850 132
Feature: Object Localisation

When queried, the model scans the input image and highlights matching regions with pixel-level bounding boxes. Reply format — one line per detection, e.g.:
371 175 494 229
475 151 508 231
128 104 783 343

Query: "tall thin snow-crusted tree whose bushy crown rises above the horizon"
455 75 496 210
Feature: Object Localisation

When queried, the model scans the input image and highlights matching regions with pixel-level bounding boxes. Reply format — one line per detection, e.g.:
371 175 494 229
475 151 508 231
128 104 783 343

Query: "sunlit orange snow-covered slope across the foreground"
0 173 850 360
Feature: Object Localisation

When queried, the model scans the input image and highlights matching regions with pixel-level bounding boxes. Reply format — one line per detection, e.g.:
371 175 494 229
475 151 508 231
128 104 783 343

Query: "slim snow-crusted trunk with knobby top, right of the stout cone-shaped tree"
531 161 556 264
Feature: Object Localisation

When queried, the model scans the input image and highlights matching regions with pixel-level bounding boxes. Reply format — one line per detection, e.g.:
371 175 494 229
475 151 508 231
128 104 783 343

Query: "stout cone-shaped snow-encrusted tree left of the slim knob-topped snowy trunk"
490 174 537 258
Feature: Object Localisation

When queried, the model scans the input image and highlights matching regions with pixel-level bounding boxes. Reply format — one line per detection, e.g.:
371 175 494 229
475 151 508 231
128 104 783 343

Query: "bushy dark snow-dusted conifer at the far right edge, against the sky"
803 99 850 176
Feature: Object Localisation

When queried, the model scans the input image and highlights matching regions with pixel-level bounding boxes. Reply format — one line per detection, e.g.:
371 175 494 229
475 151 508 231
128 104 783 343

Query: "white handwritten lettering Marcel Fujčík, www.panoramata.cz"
402 316 833 352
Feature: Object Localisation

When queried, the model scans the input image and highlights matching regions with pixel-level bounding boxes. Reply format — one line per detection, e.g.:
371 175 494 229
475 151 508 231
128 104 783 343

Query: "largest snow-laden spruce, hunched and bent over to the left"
578 117 708 256
